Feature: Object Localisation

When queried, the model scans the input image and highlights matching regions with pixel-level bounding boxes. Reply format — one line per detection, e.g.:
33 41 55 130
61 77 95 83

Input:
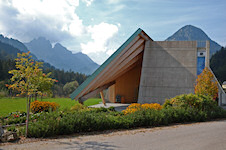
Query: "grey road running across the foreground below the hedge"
0 120 226 150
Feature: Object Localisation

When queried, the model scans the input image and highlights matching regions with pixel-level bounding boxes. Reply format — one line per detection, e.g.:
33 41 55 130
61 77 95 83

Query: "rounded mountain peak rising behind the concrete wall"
166 25 221 56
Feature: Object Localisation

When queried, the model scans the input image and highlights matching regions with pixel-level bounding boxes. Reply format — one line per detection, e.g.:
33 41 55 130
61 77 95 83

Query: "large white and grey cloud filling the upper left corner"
0 0 85 42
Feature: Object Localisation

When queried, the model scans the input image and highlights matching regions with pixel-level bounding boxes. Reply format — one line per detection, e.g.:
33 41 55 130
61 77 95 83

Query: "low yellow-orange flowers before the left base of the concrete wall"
122 103 162 115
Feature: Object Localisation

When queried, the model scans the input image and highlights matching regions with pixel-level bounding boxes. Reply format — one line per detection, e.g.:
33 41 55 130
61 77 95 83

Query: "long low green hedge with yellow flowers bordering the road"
17 94 226 137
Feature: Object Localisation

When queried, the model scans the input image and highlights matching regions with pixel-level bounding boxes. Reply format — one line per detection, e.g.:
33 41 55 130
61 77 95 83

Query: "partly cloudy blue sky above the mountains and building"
0 0 226 64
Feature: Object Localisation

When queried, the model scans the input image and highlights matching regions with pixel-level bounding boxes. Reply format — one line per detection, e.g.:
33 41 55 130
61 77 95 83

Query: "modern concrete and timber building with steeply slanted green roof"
71 29 226 105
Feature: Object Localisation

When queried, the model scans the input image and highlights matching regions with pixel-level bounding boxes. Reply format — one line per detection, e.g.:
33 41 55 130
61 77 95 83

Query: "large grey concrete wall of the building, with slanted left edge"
138 41 197 104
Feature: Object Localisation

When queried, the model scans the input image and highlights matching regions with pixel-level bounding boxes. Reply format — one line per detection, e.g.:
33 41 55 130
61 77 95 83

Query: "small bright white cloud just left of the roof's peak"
81 22 118 54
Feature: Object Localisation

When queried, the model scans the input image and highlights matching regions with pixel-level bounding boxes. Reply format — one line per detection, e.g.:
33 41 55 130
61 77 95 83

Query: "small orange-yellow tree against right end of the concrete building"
195 67 218 100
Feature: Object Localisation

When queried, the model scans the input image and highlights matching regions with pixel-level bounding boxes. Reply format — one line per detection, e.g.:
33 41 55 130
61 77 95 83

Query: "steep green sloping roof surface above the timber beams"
70 28 142 100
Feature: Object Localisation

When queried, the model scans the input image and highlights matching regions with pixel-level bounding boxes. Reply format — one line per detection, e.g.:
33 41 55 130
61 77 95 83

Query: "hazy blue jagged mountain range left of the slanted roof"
25 37 99 74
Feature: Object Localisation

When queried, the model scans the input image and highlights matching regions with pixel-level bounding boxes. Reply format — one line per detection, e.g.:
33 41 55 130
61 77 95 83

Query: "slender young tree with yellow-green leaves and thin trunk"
6 52 56 136
